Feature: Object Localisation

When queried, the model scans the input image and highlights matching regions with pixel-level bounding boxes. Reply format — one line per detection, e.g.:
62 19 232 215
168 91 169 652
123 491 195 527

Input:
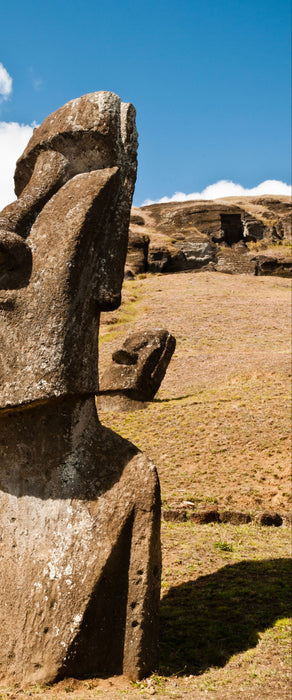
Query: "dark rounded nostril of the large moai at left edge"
0 231 32 289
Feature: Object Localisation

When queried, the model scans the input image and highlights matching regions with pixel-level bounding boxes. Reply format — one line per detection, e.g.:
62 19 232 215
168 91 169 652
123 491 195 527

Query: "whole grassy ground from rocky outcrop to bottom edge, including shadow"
0 272 291 700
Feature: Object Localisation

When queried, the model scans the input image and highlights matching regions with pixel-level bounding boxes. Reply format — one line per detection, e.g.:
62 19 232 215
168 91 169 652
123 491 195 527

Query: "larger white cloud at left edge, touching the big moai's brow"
0 122 35 211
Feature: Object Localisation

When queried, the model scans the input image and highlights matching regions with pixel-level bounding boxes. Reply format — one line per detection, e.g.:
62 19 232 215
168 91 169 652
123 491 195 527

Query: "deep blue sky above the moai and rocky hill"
0 0 291 205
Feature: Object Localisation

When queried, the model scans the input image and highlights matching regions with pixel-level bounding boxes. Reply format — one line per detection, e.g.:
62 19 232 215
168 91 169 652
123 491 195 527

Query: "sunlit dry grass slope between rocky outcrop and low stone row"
100 272 291 513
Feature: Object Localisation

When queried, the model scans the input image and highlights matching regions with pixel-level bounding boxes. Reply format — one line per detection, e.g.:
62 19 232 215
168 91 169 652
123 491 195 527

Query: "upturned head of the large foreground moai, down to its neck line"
0 92 137 411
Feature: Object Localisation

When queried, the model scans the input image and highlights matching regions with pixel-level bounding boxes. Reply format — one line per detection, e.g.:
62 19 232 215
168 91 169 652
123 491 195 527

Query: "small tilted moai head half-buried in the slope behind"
100 329 176 406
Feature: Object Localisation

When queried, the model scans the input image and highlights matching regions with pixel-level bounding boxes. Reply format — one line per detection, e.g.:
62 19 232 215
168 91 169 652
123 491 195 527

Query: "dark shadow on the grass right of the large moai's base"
160 559 292 675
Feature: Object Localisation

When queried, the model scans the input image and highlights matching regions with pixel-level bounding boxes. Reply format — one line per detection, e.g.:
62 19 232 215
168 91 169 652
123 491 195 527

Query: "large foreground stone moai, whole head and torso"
0 92 160 684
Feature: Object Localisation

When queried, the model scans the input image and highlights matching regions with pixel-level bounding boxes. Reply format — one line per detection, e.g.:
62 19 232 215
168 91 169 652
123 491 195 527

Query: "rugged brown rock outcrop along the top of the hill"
126 196 292 277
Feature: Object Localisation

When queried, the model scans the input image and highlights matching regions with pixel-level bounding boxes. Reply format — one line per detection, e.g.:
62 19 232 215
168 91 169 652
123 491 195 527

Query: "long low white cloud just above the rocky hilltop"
142 180 292 206
